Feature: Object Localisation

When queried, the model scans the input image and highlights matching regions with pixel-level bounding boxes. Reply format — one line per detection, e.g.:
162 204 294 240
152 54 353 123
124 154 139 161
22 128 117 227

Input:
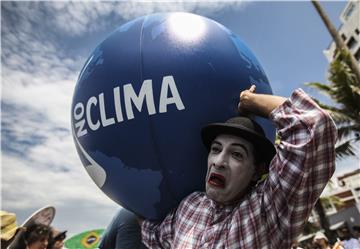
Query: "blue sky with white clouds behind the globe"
1 1 360 237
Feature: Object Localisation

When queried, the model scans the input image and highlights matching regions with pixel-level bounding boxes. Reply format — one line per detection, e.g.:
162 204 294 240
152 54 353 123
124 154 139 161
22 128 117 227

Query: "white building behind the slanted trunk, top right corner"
324 0 360 64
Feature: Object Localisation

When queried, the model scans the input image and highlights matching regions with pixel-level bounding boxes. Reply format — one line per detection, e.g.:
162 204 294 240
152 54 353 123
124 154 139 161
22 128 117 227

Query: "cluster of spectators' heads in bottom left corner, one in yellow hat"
0 211 67 249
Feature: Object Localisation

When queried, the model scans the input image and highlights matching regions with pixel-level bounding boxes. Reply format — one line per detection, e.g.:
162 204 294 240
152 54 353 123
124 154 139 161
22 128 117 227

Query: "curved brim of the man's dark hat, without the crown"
201 123 276 171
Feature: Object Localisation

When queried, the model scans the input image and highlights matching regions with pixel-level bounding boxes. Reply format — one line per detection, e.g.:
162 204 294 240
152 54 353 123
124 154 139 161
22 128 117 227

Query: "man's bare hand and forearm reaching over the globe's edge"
238 85 286 118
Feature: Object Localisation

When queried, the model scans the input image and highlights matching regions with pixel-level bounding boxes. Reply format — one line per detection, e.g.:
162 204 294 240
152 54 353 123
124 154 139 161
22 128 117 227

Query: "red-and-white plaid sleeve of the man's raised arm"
263 89 337 248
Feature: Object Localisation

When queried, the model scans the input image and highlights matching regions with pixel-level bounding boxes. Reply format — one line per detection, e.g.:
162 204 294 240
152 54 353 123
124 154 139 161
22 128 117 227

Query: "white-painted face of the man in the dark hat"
206 134 257 204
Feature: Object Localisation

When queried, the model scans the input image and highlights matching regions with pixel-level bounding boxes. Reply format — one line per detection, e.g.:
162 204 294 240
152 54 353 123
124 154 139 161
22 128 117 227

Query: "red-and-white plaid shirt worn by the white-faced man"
142 89 336 249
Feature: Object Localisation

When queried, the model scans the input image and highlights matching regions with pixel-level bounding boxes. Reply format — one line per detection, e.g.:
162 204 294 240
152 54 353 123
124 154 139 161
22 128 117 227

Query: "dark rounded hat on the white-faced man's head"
201 116 276 171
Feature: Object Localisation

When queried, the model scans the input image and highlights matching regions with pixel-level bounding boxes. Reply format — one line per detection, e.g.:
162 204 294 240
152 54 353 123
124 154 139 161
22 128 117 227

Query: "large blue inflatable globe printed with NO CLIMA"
71 13 274 219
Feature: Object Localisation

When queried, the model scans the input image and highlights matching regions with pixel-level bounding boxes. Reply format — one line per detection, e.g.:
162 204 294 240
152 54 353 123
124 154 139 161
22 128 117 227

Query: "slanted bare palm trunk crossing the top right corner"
311 0 360 85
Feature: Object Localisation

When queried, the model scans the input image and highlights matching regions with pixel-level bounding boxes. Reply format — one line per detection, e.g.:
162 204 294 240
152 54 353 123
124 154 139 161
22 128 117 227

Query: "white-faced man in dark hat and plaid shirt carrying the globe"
100 86 336 249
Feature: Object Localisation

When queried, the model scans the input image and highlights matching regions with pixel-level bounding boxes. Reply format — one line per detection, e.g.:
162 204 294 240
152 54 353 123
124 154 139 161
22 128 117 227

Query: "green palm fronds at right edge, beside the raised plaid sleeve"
307 50 360 159
